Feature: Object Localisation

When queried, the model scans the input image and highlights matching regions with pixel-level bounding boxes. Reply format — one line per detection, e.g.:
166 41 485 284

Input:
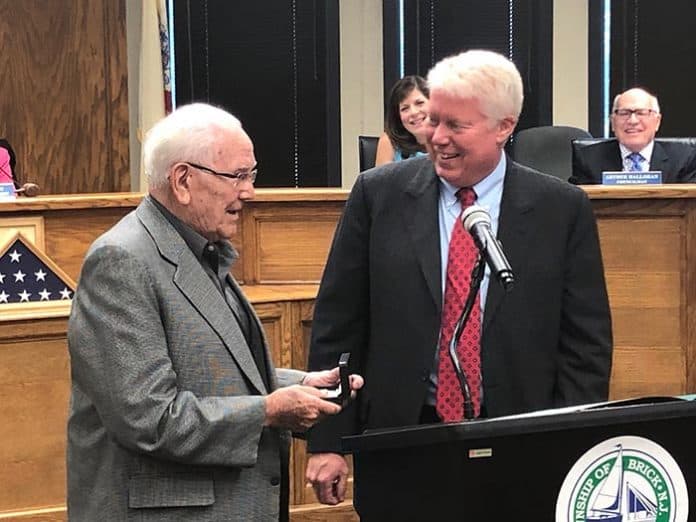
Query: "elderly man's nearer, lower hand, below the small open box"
265 384 341 432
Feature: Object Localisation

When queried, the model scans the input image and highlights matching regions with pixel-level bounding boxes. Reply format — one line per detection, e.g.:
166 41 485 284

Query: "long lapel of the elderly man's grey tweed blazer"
138 198 267 393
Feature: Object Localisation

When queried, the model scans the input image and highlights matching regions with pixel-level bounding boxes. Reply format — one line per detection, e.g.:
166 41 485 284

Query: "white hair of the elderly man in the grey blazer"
143 103 242 188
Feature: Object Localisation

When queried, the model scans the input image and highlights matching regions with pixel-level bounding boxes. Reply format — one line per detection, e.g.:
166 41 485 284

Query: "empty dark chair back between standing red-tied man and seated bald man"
510 125 592 180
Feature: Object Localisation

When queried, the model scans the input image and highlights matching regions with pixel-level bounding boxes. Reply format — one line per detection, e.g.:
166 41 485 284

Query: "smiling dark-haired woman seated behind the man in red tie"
375 76 430 166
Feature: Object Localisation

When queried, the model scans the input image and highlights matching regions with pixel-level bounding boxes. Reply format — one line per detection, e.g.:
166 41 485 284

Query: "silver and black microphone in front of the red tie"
462 205 515 292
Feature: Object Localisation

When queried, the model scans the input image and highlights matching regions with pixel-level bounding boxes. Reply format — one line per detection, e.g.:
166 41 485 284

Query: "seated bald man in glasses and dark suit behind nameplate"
569 89 696 185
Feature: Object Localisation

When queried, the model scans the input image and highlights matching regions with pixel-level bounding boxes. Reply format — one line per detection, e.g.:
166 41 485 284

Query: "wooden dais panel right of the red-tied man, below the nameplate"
593 191 695 399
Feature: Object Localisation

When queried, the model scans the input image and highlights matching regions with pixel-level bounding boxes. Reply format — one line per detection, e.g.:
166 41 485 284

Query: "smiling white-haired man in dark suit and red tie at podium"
307 51 612 511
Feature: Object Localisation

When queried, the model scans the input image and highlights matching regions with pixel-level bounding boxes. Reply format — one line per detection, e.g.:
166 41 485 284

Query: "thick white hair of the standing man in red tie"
428 50 524 120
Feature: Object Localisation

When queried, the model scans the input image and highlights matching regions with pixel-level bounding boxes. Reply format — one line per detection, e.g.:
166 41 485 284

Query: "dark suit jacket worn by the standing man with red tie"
309 158 612 452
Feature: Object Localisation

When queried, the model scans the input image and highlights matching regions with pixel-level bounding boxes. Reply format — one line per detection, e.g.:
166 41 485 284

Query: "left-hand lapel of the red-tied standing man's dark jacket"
400 161 442 313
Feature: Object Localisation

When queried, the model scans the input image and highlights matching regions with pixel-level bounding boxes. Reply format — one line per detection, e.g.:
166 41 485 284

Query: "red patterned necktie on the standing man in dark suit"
435 187 481 422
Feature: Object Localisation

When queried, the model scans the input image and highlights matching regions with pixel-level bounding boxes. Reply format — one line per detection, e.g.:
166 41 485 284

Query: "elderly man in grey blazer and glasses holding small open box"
67 104 362 522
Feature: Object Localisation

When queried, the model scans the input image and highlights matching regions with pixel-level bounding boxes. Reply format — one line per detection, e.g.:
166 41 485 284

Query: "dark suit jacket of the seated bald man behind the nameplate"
569 139 696 185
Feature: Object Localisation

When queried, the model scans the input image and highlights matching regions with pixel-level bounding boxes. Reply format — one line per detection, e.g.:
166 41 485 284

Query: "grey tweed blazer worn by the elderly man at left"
67 198 304 522
